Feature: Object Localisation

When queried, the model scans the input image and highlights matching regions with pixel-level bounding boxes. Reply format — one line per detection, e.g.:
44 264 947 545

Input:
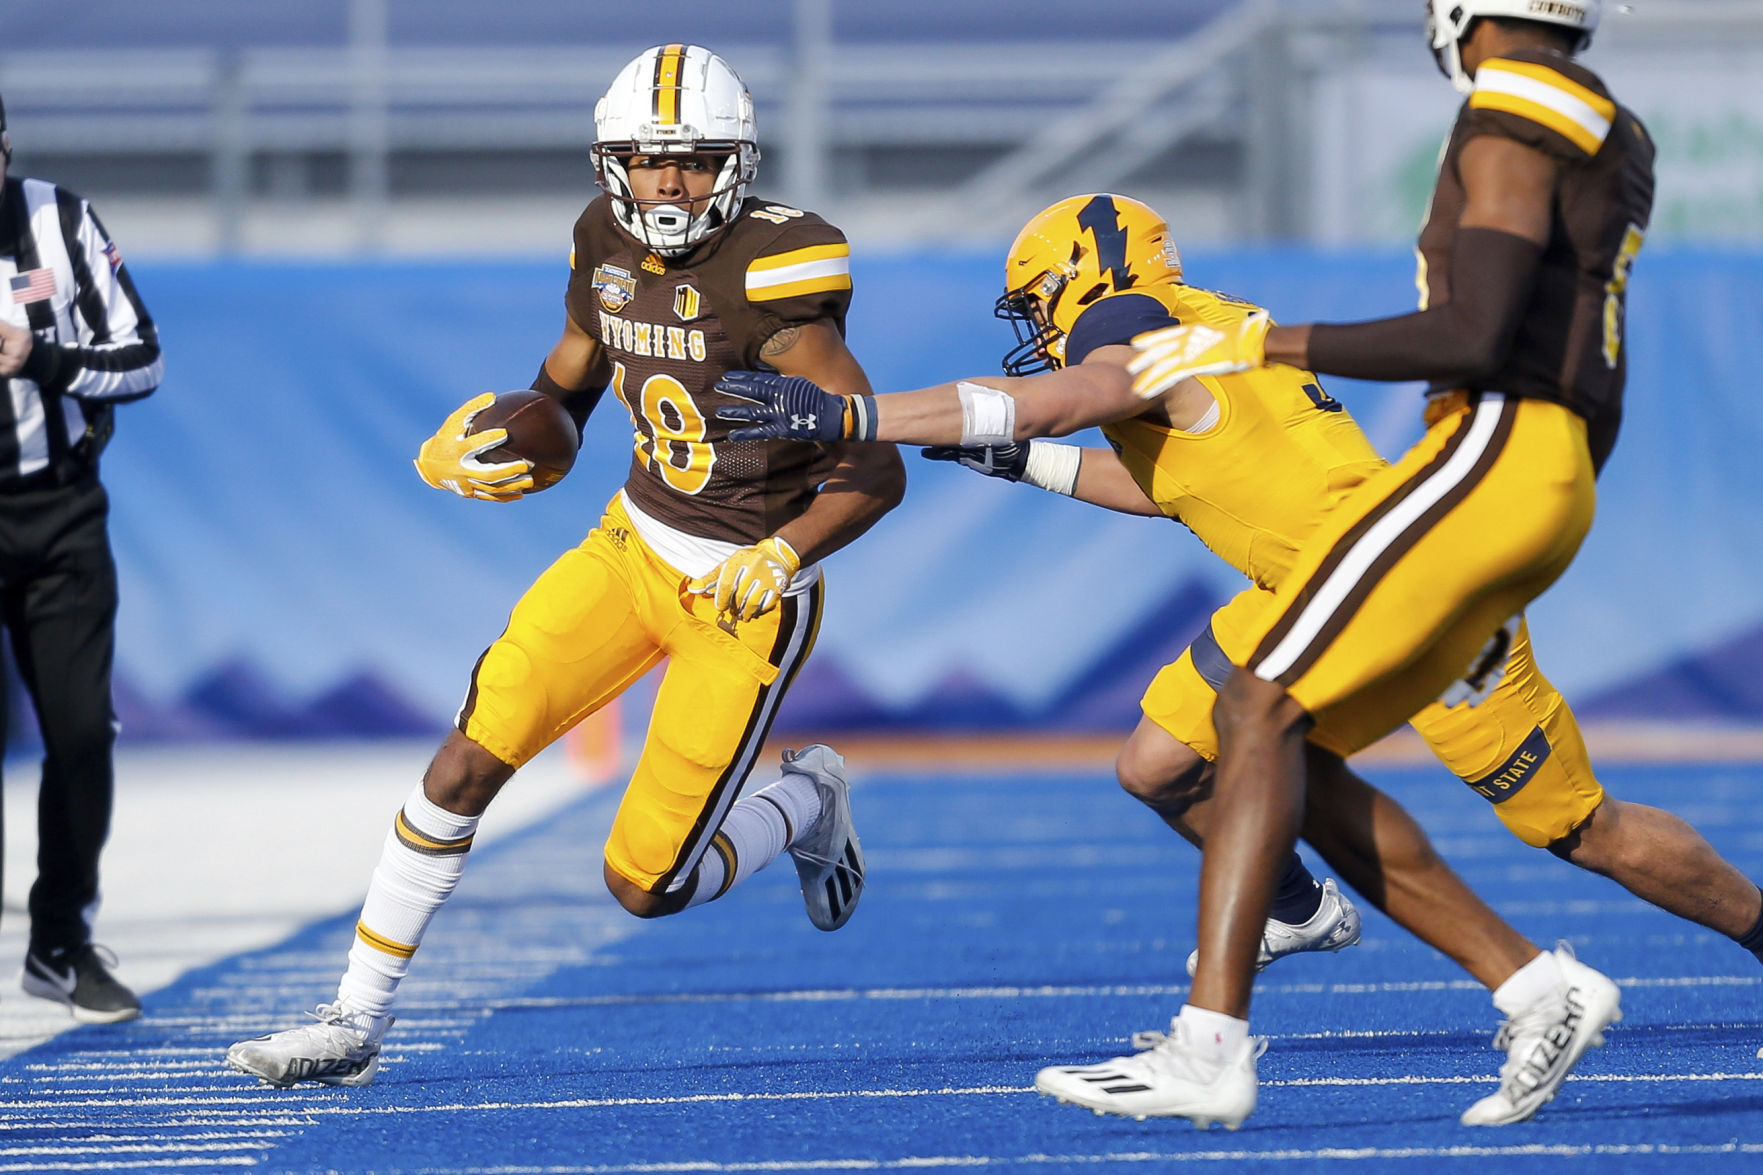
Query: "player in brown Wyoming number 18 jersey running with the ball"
227 44 904 1087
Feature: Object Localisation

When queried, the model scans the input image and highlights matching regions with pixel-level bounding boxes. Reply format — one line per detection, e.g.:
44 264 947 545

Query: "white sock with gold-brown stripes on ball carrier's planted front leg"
337 783 478 1016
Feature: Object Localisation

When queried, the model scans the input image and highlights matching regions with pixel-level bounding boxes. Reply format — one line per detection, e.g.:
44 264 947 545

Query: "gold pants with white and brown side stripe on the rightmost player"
1218 393 1596 752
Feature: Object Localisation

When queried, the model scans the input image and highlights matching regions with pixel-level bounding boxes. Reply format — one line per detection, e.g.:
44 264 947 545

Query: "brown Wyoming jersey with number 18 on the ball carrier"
564 196 852 545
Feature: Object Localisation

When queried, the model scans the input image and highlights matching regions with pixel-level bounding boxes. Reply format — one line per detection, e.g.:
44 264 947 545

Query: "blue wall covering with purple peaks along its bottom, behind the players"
27 251 1763 741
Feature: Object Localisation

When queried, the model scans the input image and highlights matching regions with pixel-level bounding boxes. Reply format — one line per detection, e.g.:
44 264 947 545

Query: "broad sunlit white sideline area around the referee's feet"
0 743 584 1058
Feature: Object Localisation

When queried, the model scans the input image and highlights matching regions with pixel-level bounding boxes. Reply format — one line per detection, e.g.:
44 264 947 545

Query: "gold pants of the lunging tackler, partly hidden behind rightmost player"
1142 606 1604 849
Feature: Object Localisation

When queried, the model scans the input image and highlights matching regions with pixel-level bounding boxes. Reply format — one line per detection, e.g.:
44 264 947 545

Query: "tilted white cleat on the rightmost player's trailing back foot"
1463 942 1622 1126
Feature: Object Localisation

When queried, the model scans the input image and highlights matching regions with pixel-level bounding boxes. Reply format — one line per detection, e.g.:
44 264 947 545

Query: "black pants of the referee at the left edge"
0 473 116 951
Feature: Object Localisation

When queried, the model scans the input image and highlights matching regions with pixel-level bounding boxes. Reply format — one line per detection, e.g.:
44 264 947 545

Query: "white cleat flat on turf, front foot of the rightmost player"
1035 1016 1268 1131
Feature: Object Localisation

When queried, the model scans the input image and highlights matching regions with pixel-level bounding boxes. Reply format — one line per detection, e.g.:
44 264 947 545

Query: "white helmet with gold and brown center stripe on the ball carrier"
594 44 760 256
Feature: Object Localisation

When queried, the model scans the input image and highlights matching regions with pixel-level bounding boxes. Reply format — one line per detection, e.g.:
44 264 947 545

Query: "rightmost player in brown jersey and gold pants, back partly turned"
1132 0 1654 1124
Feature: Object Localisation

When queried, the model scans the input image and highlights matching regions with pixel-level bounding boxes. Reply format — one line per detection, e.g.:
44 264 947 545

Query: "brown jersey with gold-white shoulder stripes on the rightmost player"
1419 49 1654 466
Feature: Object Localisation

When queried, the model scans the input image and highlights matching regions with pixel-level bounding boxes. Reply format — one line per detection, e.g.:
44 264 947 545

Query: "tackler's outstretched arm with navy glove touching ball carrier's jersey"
716 362 1144 445
